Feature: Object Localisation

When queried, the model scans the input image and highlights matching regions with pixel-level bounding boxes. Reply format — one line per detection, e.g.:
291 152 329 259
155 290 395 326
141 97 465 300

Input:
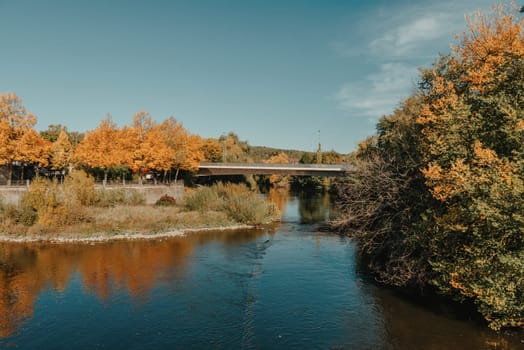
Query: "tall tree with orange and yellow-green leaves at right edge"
418 7 524 329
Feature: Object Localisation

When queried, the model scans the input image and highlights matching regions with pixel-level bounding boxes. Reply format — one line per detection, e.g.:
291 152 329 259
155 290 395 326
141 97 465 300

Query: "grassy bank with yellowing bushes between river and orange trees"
0 171 280 239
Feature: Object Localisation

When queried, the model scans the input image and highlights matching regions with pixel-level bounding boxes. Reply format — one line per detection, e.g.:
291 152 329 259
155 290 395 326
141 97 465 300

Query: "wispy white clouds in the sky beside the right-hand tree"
331 0 498 120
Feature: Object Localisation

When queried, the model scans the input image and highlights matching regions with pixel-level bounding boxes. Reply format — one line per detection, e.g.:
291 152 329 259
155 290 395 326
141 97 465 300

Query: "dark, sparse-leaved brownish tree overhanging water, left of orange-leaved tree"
332 95 434 289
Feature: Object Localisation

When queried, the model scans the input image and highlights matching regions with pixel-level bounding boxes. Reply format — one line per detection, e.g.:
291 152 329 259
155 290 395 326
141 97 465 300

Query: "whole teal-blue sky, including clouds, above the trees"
0 0 500 152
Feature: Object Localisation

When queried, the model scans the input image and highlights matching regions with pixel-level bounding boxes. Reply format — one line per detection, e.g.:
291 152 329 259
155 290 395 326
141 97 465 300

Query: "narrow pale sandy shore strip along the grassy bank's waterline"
0 225 255 244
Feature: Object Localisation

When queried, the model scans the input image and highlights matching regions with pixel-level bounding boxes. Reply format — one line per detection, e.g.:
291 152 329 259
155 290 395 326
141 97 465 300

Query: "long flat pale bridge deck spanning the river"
197 163 353 177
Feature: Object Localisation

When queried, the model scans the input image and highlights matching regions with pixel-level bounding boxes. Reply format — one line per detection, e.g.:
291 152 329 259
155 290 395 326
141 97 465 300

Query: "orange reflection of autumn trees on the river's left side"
0 230 264 338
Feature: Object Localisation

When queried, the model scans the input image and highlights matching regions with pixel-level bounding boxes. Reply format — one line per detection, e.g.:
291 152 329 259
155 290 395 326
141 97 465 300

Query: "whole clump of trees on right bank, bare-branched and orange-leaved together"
333 8 524 329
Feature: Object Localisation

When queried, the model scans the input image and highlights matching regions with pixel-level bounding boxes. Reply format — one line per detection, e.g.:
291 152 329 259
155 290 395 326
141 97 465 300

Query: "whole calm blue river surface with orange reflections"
0 195 524 349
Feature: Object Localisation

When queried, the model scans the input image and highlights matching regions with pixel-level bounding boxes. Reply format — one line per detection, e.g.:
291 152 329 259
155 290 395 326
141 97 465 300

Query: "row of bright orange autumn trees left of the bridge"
0 94 222 184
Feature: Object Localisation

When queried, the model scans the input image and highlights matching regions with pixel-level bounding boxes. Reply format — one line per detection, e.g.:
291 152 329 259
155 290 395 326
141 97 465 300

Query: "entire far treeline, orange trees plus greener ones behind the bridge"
0 93 344 185
